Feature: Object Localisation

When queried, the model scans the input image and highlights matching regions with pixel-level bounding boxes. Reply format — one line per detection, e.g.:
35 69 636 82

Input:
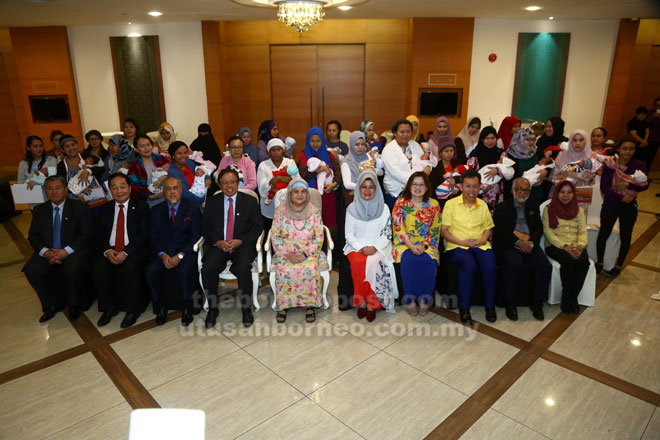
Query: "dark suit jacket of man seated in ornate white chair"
202 192 263 247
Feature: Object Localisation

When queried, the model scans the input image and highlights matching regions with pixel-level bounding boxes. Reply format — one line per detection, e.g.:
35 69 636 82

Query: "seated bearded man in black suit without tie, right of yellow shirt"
493 177 552 321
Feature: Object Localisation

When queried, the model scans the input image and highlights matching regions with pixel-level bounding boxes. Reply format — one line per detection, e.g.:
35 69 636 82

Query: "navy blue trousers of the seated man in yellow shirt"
447 248 497 310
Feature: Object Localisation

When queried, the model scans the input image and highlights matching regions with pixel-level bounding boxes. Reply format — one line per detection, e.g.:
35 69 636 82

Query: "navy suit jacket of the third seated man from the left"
151 198 202 256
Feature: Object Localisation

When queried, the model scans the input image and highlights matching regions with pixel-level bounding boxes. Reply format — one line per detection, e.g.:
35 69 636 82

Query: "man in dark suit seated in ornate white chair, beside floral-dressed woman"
202 168 263 328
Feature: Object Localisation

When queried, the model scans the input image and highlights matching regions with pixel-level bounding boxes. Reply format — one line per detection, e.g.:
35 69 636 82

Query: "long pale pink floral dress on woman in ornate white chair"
271 210 323 311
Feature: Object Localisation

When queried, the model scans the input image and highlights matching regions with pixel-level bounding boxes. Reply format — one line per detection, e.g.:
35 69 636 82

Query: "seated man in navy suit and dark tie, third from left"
147 177 202 327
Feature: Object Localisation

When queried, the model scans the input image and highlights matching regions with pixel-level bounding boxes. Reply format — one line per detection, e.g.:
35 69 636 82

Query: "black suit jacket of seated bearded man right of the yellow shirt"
493 197 543 251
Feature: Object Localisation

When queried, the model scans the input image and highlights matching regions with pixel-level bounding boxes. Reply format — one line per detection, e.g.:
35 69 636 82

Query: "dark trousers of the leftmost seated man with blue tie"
23 252 89 311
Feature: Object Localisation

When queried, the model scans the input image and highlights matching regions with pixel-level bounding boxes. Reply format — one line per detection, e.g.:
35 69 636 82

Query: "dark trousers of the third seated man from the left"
146 252 197 303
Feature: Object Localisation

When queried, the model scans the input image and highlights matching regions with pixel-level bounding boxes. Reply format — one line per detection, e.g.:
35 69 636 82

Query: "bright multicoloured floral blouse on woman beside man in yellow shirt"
392 197 442 263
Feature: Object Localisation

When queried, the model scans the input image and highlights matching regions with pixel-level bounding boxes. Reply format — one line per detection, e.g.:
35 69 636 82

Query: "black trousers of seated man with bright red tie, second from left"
92 253 148 313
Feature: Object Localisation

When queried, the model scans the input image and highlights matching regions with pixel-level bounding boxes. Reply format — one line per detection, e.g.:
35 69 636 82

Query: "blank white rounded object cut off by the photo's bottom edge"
128 408 206 440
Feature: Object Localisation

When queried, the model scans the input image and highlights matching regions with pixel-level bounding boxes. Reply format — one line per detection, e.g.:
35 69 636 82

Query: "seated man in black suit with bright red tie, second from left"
92 173 150 328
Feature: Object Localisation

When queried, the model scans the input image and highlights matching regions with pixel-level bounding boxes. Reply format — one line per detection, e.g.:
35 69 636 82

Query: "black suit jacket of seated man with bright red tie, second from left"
96 198 151 255
